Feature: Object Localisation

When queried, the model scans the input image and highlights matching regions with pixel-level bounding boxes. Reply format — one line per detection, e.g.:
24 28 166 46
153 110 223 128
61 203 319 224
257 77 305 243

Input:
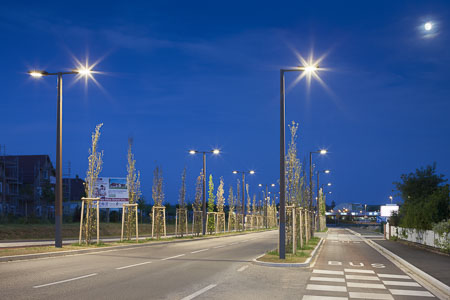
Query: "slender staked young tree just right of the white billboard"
126 138 141 240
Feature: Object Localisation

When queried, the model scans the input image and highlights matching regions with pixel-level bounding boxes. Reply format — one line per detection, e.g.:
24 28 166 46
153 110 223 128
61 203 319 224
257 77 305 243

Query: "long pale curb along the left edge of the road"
0 230 278 263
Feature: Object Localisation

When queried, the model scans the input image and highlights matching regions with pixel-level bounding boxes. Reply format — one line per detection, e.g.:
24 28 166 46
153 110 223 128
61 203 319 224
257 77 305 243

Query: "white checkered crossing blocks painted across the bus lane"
302 268 435 300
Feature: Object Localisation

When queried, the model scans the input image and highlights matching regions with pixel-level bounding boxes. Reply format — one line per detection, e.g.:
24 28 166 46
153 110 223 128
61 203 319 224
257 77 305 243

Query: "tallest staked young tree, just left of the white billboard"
84 123 103 244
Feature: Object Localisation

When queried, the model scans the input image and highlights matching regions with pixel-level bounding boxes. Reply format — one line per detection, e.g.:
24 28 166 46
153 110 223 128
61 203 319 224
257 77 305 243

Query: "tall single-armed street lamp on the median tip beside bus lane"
279 64 319 259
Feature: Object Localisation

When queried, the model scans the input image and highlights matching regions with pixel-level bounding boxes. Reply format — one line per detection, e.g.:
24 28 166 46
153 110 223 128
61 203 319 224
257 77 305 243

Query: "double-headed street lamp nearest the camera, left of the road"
28 67 93 248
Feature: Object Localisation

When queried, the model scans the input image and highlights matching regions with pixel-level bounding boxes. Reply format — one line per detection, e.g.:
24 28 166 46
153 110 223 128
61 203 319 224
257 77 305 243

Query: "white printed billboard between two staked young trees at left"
94 177 128 208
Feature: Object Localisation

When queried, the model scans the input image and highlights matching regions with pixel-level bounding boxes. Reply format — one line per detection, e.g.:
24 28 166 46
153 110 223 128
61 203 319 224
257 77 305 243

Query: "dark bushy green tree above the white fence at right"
394 164 450 230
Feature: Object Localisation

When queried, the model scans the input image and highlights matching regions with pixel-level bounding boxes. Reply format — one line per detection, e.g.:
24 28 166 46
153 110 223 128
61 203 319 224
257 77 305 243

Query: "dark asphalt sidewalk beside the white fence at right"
372 240 450 286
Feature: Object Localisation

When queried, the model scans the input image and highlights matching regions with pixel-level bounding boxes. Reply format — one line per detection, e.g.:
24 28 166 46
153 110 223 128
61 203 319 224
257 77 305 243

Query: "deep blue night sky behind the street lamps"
0 1 450 204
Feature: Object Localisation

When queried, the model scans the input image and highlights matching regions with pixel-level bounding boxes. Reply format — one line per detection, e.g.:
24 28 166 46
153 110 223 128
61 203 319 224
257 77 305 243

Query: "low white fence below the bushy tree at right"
385 223 450 249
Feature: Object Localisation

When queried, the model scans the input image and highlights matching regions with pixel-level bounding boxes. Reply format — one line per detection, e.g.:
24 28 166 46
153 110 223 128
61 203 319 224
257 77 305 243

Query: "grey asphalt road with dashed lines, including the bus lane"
0 229 442 300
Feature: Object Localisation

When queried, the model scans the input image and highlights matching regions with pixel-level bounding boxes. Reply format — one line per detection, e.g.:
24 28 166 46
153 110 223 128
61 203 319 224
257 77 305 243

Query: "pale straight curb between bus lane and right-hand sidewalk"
347 229 450 300
